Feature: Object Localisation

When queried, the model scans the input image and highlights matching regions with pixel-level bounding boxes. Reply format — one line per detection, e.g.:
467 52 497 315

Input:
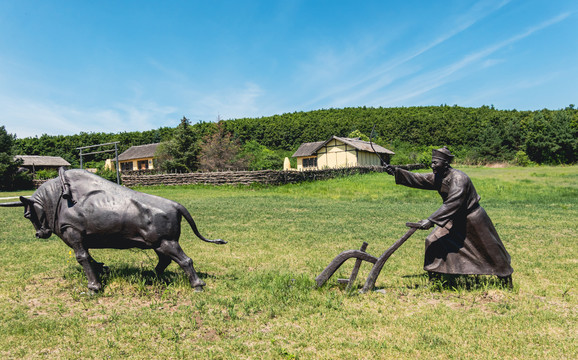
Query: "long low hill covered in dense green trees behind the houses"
16 105 578 164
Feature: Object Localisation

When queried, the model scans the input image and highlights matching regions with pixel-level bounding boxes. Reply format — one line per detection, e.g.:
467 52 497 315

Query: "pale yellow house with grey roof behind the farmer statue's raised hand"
293 136 395 170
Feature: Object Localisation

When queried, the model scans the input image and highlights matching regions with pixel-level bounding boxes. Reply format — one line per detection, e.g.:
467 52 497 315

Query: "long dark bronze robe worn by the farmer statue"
395 168 514 277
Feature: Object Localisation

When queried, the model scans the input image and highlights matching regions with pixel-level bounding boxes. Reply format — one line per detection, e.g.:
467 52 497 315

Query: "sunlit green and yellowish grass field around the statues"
0 166 578 359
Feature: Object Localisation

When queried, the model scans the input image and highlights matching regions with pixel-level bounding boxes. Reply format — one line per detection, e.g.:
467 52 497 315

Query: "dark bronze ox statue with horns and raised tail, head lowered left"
0 168 227 291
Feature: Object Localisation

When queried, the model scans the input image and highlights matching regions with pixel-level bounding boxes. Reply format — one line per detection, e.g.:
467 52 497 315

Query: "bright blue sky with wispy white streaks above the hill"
0 0 578 138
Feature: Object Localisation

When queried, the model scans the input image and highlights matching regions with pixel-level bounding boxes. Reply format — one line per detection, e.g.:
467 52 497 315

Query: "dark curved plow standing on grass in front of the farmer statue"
315 222 420 294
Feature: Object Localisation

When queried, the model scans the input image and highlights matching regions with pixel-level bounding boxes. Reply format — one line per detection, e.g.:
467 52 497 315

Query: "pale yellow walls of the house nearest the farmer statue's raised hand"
297 139 380 170
